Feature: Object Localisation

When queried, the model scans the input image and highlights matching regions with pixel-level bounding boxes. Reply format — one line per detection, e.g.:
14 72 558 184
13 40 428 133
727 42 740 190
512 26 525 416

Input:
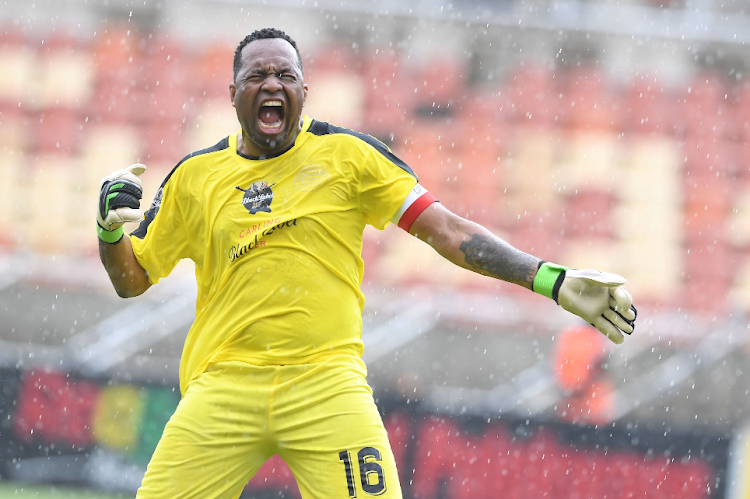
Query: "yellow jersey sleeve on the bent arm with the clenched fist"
130 170 188 284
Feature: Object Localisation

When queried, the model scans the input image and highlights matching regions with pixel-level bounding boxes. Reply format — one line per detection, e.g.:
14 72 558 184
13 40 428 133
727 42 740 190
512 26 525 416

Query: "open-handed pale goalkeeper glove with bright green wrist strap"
533 262 638 343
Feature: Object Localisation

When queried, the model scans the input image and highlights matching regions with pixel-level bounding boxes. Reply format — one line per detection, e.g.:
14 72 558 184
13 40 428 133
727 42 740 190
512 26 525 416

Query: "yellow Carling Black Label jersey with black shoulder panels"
130 116 426 393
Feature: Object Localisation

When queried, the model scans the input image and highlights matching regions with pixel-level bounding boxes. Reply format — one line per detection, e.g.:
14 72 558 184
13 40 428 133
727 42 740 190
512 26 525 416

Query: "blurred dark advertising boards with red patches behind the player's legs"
0 368 732 499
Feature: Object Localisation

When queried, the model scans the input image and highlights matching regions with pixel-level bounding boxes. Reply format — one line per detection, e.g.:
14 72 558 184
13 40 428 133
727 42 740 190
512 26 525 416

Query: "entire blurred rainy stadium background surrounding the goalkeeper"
0 0 750 499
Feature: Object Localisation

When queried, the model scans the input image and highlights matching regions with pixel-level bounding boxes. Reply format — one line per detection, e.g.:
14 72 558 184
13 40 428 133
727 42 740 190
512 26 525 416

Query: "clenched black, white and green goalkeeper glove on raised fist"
96 164 146 244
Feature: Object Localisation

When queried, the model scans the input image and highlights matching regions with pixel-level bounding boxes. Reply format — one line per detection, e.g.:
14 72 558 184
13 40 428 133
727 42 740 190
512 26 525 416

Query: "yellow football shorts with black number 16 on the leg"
136 355 401 499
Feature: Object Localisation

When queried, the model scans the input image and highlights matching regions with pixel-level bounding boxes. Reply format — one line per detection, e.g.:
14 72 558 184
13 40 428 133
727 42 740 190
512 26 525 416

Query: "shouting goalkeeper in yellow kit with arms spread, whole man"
97 29 635 499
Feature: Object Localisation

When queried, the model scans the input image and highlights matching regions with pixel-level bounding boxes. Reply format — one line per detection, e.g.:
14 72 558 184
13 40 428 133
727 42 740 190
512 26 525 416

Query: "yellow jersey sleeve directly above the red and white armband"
359 142 417 230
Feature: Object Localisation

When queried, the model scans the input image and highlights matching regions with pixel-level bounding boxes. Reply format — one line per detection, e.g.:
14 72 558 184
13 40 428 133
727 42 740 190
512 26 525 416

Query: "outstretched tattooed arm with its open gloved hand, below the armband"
409 203 637 343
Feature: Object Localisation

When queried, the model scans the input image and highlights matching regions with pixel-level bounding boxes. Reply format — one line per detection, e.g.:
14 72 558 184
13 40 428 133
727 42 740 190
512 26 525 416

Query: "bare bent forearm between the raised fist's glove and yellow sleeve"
99 236 151 298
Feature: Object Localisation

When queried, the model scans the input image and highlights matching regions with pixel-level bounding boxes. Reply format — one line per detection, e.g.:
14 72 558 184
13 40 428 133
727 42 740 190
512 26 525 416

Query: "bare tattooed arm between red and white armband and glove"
409 203 541 289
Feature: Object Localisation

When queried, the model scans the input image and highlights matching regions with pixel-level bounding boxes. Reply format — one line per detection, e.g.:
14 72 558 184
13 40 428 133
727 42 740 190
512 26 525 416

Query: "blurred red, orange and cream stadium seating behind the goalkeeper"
0 25 750 313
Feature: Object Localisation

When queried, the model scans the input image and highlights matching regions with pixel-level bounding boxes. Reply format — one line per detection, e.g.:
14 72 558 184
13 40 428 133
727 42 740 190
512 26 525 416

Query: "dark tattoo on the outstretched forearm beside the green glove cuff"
459 234 539 288
